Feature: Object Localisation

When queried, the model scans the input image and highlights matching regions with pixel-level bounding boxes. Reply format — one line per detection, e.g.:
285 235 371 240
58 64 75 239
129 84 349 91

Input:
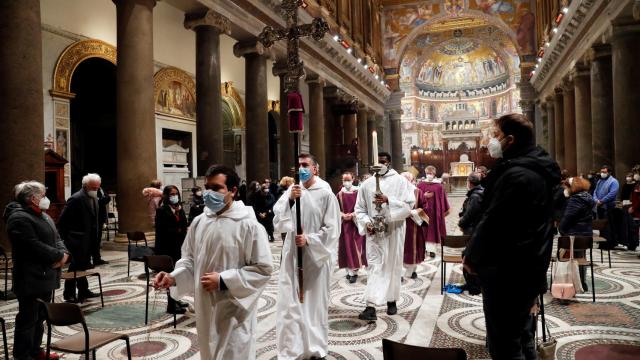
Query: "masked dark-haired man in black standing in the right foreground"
463 114 560 359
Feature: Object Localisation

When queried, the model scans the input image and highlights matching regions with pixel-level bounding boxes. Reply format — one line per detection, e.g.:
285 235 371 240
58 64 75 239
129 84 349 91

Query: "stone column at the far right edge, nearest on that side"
611 19 640 179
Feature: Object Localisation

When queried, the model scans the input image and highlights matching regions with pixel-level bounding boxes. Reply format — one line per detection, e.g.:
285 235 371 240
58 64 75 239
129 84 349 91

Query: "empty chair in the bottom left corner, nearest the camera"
38 300 131 360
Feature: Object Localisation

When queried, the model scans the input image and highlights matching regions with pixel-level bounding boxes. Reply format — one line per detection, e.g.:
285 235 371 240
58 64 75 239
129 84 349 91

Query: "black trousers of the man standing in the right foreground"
480 271 537 360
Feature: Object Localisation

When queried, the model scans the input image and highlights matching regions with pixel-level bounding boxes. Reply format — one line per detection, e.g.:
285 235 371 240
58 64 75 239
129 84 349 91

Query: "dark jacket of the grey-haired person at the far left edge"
4 201 67 296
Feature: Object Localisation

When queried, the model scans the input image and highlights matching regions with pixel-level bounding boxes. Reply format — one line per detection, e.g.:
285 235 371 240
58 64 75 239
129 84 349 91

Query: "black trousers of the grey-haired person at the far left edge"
13 292 51 360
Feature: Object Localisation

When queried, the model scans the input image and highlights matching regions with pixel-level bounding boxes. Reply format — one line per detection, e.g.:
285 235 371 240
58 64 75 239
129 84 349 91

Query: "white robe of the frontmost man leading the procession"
171 201 273 360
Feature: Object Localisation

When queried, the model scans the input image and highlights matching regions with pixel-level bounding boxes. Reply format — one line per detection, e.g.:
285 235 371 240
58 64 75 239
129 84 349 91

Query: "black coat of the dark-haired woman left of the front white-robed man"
155 205 187 264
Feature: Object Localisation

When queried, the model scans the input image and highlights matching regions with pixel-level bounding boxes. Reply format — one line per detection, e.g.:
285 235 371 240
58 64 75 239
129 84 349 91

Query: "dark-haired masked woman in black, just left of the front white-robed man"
155 185 187 314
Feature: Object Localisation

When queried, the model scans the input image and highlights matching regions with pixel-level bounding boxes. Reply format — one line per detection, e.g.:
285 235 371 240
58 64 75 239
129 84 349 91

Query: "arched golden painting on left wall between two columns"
154 67 196 120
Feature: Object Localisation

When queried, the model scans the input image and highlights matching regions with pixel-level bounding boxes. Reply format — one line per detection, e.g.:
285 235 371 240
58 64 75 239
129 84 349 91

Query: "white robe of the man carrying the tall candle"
355 169 416 306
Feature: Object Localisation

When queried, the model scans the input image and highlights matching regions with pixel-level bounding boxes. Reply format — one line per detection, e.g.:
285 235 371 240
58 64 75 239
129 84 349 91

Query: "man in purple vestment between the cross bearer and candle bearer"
336 172 367 284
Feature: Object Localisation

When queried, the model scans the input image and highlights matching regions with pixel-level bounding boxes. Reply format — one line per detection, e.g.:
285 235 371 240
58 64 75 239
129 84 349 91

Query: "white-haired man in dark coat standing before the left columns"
58 174 102 303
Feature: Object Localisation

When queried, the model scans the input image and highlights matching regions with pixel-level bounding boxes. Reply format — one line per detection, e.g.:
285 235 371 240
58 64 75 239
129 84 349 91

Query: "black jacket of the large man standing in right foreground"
465 146 560 298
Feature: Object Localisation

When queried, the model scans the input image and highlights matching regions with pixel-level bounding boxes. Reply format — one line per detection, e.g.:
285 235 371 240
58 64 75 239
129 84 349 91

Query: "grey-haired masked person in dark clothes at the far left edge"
4 181 69 360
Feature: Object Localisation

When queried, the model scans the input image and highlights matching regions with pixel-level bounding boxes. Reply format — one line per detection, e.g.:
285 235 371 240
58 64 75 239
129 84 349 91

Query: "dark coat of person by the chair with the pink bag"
558 191 595 236
